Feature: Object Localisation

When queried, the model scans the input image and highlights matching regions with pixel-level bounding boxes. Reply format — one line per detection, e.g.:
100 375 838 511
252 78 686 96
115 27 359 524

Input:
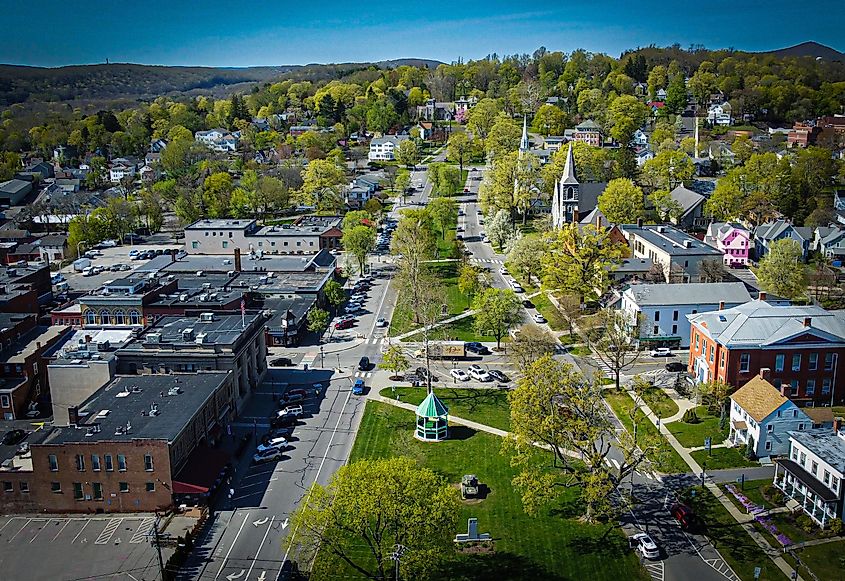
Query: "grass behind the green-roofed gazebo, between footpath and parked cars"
379 387 511 431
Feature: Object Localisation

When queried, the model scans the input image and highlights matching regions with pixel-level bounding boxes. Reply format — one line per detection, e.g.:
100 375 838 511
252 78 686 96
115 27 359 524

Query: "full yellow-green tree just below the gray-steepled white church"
541 224 627 302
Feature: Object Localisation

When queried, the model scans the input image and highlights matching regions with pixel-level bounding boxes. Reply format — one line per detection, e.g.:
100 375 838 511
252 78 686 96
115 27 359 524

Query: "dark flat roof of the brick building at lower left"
43 371 229 445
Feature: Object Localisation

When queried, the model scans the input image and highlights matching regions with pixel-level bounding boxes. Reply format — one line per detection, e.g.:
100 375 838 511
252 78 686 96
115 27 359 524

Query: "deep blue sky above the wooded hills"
0 0 845 66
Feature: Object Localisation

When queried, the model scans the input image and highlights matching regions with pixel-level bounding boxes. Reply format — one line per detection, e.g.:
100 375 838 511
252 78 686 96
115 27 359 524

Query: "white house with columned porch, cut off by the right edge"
774 420 845 528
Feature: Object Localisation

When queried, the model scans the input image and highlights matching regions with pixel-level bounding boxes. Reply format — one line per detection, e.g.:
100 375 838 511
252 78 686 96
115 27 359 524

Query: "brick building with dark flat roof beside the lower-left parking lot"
0 372 235 513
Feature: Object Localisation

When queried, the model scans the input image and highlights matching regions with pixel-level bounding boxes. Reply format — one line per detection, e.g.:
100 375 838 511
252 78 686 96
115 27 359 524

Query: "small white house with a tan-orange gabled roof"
728 369 813 458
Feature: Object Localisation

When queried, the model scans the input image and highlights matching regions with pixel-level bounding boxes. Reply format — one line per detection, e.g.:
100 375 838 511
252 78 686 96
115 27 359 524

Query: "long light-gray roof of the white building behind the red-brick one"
625 282 751 306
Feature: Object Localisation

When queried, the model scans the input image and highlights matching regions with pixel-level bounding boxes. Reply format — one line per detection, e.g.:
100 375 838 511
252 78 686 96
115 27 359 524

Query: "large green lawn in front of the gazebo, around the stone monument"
310 402 648 581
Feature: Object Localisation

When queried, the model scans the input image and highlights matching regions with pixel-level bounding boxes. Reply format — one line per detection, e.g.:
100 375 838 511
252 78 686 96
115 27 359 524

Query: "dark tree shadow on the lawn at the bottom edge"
431 552 566 581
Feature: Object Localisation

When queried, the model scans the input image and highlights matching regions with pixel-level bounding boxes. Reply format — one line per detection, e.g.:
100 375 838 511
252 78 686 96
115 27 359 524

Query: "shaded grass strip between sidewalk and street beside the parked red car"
684 486 792 580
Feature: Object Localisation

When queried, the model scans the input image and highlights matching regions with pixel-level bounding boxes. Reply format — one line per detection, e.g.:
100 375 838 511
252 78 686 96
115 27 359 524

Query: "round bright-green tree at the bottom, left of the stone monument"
287 458 460 580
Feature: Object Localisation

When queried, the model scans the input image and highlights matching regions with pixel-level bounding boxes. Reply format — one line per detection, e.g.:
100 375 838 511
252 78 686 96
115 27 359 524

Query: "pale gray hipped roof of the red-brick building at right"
687 300 845 346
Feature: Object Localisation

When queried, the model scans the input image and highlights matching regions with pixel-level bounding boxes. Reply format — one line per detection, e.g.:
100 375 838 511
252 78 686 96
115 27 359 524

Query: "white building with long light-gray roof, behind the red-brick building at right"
620 282 751 348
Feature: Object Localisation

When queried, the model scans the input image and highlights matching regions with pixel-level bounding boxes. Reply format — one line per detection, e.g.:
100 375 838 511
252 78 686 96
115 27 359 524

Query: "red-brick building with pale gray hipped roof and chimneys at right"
687 302 845 407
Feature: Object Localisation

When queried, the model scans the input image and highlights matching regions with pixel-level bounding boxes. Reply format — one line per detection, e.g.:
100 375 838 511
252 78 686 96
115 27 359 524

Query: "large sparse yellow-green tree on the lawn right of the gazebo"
502 355 659 522
